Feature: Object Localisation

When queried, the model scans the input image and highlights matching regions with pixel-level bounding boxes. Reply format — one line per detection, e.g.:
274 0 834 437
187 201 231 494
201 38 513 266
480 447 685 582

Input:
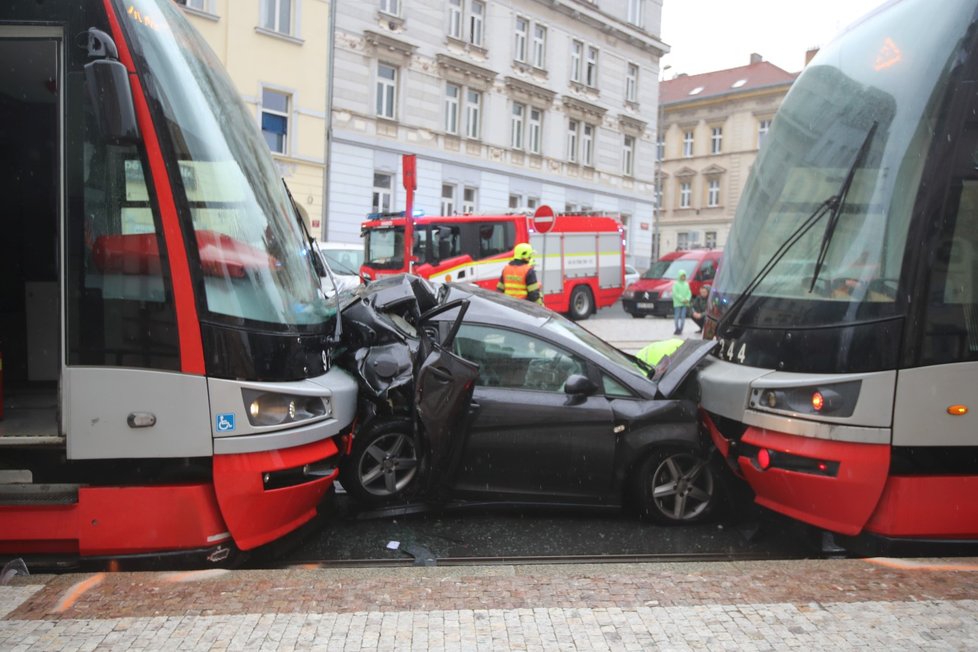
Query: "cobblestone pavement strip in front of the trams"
0 558 978 650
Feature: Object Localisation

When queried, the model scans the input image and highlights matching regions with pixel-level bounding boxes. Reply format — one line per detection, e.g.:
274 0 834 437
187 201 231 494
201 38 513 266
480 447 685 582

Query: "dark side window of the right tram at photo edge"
923 180 978 364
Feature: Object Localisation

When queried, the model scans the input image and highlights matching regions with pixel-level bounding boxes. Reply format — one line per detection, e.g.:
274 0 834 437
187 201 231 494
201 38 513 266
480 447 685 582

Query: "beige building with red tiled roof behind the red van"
656 55 797 254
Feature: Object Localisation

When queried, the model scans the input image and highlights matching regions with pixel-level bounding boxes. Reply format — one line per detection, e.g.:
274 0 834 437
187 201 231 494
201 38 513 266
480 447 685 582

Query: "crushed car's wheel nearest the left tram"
340 419 419 506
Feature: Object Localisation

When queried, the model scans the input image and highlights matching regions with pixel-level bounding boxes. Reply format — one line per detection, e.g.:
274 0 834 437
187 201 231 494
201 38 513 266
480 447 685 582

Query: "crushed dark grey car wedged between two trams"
340 275 718 523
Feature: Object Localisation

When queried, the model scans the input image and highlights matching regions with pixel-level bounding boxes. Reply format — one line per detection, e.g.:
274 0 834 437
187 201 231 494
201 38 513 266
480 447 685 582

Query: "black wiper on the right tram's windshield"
717 121 879 337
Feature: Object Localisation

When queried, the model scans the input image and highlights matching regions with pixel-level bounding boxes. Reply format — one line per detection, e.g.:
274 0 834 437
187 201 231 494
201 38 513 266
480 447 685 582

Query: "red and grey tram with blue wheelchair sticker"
0 0 356 563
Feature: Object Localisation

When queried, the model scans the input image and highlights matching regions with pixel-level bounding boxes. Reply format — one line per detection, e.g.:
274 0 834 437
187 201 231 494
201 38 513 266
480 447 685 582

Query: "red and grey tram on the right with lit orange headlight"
700 0 978 550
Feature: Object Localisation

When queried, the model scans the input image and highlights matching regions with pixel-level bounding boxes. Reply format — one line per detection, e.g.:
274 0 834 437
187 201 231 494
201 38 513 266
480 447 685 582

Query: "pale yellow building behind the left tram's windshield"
177 0 330 235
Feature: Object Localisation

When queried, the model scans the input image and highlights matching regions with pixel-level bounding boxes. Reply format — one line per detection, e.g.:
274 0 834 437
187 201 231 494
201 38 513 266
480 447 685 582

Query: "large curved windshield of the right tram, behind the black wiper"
714 0 974 327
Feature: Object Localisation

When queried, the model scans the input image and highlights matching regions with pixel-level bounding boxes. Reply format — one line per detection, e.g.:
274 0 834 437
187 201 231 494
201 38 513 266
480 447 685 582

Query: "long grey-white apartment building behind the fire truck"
326 0 668 266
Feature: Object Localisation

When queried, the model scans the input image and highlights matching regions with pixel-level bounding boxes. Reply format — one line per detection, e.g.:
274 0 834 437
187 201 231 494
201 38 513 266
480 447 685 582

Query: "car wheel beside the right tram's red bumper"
633 448 718 525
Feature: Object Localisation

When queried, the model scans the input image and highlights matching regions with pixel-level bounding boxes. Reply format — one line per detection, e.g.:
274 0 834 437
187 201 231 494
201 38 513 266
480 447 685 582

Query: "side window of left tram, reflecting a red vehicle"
66 75 180 369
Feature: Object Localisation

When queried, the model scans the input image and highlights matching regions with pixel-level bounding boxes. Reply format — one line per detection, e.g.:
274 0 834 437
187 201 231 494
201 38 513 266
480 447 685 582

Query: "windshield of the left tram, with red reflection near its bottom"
118 0 333 327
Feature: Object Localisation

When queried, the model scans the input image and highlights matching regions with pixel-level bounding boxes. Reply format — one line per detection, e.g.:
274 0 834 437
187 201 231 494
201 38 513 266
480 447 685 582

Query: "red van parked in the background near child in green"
621 249 723 318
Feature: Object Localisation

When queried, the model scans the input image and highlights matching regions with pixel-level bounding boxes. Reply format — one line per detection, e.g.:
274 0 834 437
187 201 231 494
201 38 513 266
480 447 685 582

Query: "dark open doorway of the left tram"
0 26 63 443
